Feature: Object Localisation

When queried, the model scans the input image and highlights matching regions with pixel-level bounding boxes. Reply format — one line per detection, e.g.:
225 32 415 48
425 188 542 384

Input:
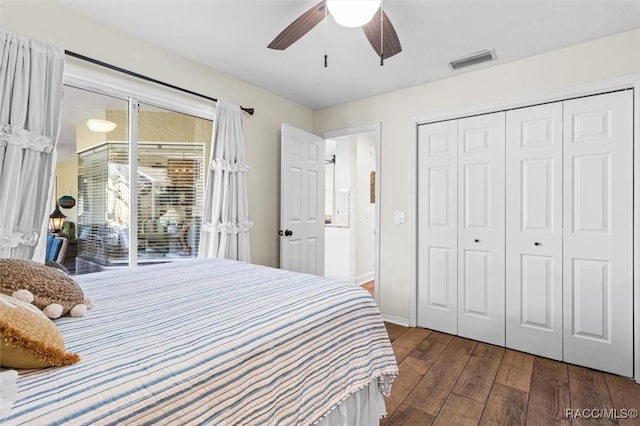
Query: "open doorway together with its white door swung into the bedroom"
279 123 380 302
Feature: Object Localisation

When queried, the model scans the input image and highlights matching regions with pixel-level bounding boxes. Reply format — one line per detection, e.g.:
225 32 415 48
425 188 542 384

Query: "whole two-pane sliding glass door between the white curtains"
55 86 212 274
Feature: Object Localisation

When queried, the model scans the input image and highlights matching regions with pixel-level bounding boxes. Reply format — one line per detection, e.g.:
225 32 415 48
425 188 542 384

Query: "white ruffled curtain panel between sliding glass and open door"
198 101 252 262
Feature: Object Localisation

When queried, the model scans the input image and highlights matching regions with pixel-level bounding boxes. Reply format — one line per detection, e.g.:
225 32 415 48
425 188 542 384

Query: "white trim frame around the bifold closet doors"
408 73 640 384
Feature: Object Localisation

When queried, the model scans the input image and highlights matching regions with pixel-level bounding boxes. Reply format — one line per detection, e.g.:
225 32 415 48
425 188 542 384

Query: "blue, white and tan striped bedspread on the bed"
0 259 398 425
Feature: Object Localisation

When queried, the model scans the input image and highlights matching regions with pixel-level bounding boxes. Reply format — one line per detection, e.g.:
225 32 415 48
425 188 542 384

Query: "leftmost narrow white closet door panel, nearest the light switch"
418 120 458 334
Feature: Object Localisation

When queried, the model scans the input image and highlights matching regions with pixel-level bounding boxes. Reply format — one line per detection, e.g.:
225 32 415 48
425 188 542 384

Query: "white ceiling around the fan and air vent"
58 0 640 109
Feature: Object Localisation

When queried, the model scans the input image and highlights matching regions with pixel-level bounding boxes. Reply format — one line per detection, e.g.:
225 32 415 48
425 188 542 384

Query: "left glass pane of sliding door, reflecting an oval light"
62 86 130 274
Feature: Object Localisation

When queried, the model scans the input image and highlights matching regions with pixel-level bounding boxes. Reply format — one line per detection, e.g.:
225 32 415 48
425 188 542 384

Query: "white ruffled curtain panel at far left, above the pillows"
0 30 64 262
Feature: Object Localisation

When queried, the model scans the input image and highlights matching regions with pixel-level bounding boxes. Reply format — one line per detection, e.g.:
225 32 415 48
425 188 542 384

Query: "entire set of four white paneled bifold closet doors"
418 91 633 376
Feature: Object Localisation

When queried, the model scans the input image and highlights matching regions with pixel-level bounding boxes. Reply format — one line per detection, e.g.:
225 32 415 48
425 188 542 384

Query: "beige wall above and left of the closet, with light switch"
315 30 640 318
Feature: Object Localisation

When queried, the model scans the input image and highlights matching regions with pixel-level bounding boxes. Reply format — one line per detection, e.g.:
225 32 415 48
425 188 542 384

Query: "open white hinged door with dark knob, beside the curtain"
280 124 324 275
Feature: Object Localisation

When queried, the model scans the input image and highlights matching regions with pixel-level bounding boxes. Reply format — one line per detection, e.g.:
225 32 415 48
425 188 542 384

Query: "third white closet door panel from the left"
506 102 562 360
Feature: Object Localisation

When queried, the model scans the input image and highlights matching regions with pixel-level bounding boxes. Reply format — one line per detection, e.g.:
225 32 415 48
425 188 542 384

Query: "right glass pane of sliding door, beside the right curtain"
137 103 213 265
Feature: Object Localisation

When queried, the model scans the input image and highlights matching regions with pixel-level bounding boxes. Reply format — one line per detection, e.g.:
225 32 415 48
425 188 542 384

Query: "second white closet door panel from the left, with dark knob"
458 112 505 346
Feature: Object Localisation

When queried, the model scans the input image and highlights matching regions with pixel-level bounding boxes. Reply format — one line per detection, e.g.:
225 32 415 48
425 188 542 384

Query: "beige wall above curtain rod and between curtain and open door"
0 0 313 266
